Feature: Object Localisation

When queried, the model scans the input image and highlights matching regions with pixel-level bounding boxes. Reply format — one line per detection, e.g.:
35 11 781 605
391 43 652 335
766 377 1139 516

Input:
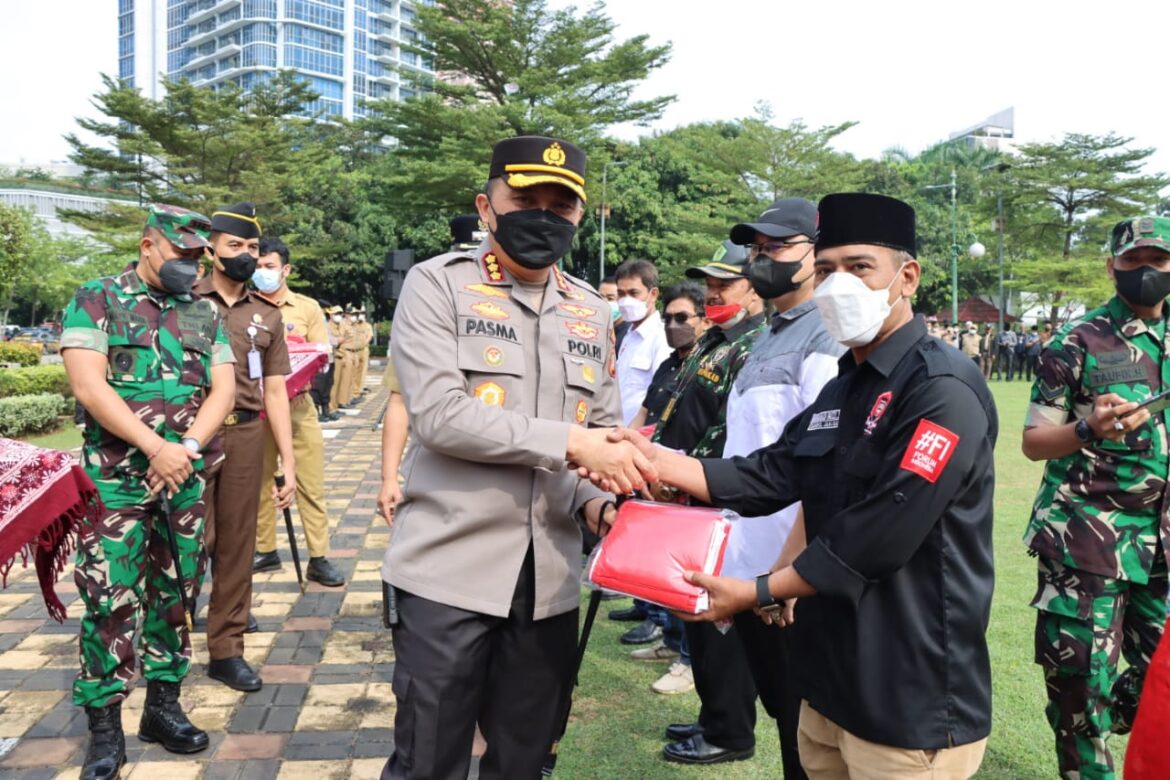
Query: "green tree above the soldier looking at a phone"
1005 133 1170 322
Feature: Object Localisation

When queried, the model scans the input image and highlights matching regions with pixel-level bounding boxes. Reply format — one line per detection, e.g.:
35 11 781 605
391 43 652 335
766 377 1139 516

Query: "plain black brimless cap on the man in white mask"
817 192 918 256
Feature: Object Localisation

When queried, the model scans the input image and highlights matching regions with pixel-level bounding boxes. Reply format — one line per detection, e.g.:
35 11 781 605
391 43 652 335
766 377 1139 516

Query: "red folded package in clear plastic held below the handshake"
589 501 731 614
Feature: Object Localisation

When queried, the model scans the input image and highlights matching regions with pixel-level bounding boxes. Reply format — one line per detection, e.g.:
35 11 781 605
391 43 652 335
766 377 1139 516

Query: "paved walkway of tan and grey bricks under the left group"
0 367 465 780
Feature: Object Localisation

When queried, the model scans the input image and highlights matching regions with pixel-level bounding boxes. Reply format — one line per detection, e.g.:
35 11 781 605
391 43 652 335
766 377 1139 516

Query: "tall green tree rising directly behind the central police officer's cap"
365 0 674 223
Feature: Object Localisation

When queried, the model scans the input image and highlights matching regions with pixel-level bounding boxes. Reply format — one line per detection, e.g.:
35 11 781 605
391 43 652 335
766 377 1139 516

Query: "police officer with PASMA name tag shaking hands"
383 137 649 780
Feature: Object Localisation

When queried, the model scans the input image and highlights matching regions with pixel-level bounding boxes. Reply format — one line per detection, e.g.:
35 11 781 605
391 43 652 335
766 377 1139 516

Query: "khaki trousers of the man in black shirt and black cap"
797 702 987 780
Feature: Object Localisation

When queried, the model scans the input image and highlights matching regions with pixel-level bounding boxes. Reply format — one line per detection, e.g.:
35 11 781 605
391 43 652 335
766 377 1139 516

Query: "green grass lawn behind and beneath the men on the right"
557 382 1126 780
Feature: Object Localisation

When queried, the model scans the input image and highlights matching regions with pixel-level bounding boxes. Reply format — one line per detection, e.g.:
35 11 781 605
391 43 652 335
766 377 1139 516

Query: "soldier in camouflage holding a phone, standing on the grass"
1024 218 1170 779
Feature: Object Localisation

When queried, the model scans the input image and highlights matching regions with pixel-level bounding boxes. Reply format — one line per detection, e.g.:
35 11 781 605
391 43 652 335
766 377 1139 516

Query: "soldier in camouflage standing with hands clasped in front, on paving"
61 206 234 779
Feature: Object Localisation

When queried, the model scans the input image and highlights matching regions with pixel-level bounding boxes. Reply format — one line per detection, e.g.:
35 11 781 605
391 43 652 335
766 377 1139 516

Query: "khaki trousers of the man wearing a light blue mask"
256 393 329 558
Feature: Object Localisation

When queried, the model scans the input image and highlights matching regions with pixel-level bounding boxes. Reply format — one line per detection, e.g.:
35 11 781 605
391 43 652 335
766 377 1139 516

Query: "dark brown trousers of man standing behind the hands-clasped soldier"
204 417 268 661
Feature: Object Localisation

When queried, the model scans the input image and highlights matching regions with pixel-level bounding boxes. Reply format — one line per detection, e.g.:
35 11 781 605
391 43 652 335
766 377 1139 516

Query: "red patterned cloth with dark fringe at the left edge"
0 437 102 622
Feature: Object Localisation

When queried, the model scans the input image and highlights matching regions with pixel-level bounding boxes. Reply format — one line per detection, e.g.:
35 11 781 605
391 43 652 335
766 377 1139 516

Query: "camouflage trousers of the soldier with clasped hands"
73 472 206 706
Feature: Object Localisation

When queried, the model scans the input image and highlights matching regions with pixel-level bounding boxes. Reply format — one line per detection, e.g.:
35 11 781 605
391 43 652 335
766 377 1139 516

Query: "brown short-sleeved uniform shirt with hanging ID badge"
194 274 290 412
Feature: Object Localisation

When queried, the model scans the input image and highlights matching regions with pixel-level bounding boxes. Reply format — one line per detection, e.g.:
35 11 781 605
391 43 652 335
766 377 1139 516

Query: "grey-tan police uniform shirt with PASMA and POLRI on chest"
381 246 621 620
